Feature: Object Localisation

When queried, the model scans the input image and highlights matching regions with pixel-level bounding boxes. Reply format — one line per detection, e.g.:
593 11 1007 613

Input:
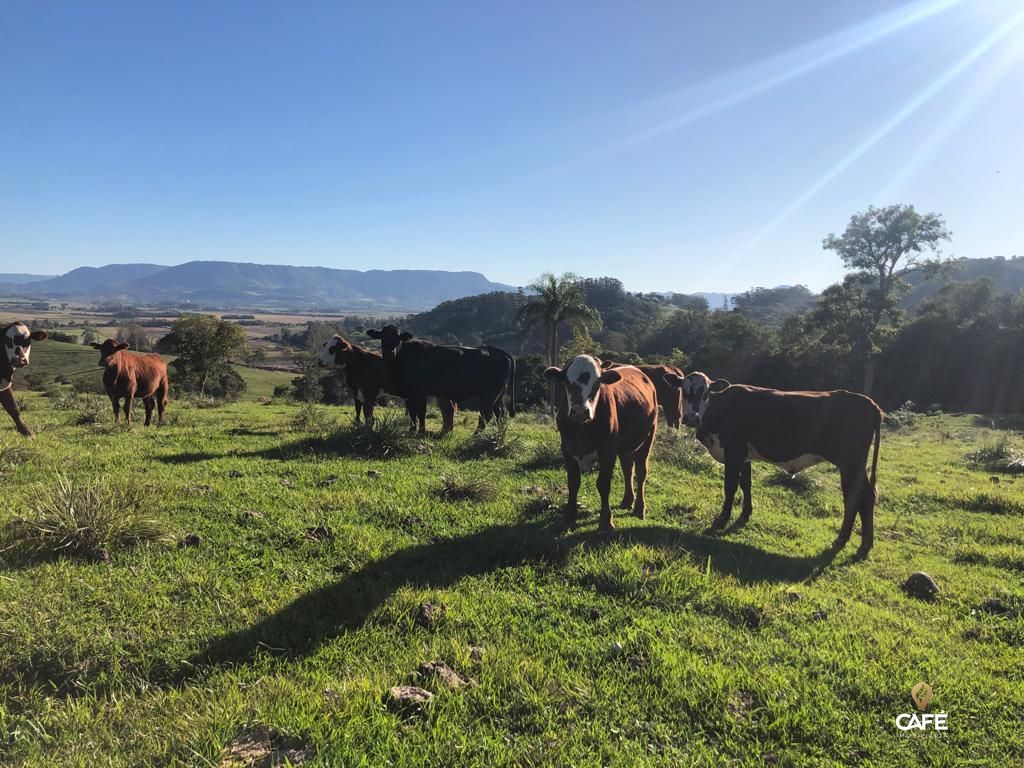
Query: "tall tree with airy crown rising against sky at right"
821 205 951 394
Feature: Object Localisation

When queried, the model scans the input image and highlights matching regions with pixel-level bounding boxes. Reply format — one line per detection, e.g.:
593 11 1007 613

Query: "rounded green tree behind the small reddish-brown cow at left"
157 314 249 394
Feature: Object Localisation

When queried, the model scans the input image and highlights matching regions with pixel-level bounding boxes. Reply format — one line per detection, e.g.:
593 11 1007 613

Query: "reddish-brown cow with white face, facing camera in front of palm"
544 354 657 530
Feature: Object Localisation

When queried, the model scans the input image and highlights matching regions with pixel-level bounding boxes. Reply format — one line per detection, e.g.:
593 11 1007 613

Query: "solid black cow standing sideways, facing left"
367 326 516 432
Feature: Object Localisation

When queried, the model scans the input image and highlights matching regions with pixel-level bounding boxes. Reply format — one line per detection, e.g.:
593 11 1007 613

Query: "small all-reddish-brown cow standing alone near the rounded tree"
90 339 170 426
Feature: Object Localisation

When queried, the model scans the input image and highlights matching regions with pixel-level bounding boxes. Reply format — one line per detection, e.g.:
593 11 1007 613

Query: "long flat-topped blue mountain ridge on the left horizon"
0 261 515 311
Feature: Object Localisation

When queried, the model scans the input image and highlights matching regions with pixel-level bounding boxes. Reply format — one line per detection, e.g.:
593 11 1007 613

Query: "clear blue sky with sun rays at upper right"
0 0 1024 292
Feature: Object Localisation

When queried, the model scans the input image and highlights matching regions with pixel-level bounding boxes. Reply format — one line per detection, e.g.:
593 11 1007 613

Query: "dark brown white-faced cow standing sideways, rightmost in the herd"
666 372 883 557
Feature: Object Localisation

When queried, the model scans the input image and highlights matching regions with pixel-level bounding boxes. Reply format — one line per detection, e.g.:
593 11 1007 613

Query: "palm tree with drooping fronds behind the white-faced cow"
519 272 601 407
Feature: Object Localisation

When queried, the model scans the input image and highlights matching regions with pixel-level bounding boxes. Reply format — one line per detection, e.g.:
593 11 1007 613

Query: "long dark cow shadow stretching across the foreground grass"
178 521 837 681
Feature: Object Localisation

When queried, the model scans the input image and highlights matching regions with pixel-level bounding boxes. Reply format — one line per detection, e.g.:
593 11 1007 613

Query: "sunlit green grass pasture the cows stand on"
0 393 1024 766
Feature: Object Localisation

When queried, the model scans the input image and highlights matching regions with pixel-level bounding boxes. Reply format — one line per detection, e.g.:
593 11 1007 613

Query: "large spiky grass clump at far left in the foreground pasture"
12 475 168 557
